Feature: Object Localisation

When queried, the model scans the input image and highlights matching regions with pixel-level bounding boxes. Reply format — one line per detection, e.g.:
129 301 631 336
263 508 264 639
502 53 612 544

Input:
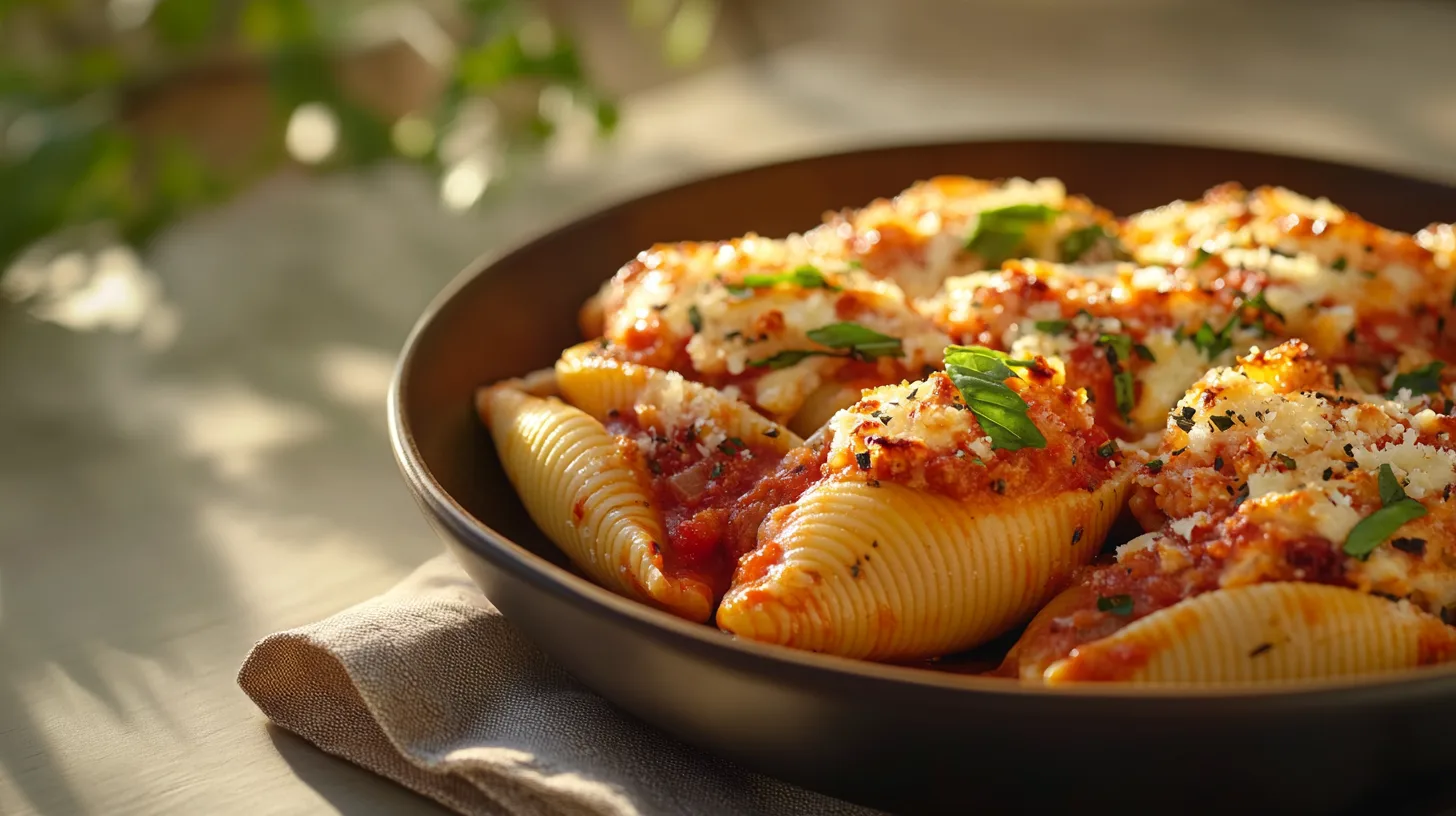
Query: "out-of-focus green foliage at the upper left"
0 0 716 271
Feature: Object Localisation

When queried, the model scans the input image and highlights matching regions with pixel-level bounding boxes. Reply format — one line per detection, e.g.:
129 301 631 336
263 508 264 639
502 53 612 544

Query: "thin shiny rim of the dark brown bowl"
386 136 1456 714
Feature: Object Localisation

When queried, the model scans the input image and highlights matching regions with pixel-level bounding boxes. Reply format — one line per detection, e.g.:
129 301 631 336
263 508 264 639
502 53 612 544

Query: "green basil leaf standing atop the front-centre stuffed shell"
945 345 1047 450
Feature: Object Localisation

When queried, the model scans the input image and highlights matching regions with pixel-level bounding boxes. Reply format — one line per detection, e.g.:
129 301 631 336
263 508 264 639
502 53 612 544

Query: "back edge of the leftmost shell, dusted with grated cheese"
556 342 804 453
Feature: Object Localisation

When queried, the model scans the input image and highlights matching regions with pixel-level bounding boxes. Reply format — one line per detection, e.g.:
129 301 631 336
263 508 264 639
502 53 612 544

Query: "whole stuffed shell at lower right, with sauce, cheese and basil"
1005 341 1456 685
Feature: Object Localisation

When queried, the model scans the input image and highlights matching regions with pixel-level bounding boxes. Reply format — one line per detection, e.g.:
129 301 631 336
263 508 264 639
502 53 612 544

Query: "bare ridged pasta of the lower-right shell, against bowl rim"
1042 583 1456 685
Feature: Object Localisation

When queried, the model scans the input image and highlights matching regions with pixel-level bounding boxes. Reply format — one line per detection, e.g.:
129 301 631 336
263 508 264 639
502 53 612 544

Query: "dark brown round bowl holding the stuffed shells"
389 141 1456 813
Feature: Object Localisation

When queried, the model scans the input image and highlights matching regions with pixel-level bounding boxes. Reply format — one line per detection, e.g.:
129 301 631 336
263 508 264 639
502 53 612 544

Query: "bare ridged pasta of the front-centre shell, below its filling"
718 471 1130 660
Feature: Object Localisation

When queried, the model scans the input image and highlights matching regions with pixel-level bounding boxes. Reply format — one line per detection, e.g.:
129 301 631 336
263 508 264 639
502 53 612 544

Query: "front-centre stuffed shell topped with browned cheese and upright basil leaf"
718 348 1131 660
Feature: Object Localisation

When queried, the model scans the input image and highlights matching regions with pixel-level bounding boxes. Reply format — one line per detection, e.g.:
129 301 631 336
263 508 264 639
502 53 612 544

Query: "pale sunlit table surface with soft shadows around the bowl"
8 0 1456 815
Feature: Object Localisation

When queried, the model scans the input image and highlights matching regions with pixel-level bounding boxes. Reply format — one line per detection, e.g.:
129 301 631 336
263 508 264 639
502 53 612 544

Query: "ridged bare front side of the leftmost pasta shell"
476 386 713 621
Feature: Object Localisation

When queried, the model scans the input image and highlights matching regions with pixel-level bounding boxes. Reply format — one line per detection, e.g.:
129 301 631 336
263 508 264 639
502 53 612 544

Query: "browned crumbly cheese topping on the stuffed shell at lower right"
1139 342 1456 609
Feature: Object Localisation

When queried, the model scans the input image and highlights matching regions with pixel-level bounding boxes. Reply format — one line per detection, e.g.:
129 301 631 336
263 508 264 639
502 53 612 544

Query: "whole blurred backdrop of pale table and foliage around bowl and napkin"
0 0 1456 815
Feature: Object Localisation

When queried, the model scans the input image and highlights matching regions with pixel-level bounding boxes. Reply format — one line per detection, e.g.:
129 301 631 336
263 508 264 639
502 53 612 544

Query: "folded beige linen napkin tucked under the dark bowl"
237 555 874 816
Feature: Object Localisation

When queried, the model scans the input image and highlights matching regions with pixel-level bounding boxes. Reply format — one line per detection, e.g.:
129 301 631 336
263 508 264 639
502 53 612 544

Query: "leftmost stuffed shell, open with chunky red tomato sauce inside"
478 344 802 621
